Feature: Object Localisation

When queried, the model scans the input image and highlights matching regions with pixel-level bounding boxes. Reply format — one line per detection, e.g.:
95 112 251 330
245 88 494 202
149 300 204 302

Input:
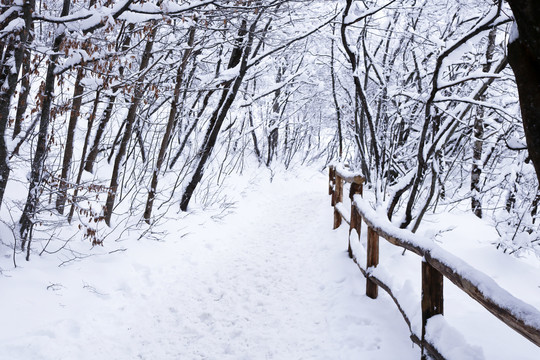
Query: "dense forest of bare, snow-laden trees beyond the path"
0 0 540 260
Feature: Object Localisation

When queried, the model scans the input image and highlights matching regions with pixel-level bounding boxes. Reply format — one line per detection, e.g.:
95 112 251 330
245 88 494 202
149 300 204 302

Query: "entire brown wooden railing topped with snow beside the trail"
329 165 540 359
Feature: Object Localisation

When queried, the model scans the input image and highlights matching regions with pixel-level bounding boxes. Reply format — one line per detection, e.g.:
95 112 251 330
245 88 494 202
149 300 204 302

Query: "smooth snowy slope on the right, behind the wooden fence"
343 174 540 360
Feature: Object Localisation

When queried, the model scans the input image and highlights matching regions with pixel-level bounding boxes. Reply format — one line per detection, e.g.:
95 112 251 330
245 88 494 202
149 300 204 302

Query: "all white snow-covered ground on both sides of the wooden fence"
0 169 540 360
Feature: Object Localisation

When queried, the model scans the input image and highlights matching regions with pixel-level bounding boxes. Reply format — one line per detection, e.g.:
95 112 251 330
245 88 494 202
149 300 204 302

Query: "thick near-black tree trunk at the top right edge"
508 0 540 183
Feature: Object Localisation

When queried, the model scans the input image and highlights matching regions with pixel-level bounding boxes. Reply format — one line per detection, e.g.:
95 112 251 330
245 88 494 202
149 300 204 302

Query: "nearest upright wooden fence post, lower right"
422 260 444 360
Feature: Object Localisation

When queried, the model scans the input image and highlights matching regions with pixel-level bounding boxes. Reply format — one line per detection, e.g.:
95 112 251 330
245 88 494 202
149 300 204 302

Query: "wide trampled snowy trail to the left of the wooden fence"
0 173 419 360
